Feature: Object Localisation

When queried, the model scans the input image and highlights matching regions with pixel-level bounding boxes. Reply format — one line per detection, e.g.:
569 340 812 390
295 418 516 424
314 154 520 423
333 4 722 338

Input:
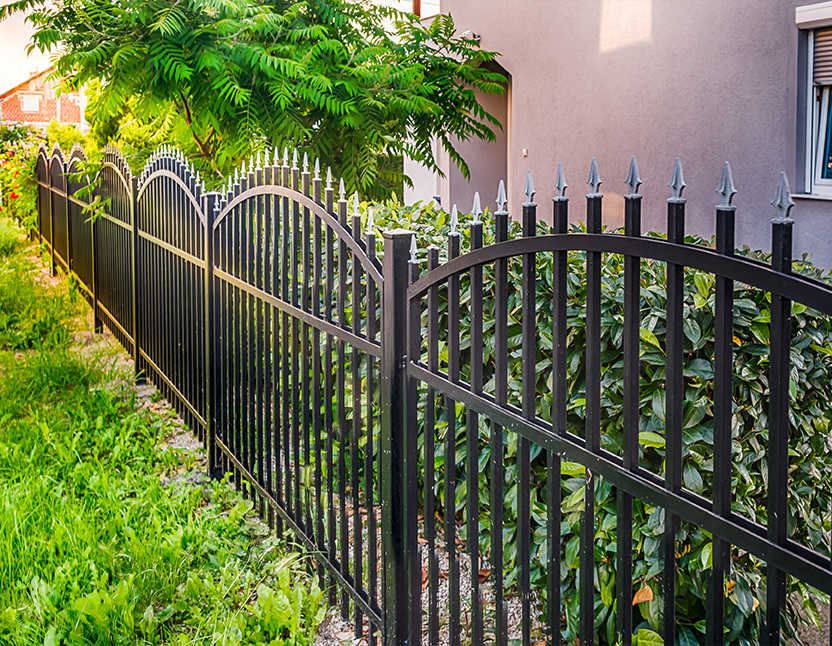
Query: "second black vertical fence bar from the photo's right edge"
705 168 736 646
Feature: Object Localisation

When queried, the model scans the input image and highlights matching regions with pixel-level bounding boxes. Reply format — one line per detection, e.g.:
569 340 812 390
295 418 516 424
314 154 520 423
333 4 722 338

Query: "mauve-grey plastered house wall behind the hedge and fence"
428 0 832 266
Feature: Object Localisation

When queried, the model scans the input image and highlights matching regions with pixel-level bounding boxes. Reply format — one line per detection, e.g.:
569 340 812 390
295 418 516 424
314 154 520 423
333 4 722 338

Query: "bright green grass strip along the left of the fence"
0 219 324 646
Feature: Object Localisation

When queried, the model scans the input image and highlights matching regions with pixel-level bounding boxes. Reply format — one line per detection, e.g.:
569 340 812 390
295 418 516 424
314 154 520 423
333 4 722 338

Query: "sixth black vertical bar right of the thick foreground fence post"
517 182 537 644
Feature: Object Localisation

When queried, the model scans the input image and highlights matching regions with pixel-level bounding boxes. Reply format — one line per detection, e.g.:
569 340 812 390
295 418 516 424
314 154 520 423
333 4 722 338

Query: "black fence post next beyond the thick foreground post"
202 193 222 480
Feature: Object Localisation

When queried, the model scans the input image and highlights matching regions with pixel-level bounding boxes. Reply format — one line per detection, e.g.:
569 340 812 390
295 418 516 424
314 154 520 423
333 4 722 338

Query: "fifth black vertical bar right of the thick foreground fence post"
491 194 508 646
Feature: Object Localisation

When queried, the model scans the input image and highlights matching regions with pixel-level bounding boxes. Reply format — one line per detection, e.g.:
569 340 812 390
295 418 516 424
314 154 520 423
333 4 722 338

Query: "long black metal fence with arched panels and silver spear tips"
37 143 832 644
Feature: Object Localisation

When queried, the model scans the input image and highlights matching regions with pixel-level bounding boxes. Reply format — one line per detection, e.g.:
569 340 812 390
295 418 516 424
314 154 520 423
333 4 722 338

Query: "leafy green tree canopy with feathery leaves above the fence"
0 0 503 195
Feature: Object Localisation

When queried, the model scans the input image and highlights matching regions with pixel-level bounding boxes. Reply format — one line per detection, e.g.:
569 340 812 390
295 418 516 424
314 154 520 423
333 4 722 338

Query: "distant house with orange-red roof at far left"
0 69 85 130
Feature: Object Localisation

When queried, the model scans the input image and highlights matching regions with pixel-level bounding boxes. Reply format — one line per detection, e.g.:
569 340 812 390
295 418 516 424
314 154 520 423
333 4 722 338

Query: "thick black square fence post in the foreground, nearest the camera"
379 229 413 646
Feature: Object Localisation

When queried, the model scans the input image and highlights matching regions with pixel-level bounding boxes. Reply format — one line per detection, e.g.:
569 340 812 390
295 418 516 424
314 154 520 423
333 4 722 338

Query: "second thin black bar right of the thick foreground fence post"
428 245 442 646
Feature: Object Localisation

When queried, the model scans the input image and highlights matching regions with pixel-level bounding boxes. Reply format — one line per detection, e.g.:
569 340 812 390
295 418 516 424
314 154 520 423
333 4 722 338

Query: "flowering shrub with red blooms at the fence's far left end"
0 123 41 226
